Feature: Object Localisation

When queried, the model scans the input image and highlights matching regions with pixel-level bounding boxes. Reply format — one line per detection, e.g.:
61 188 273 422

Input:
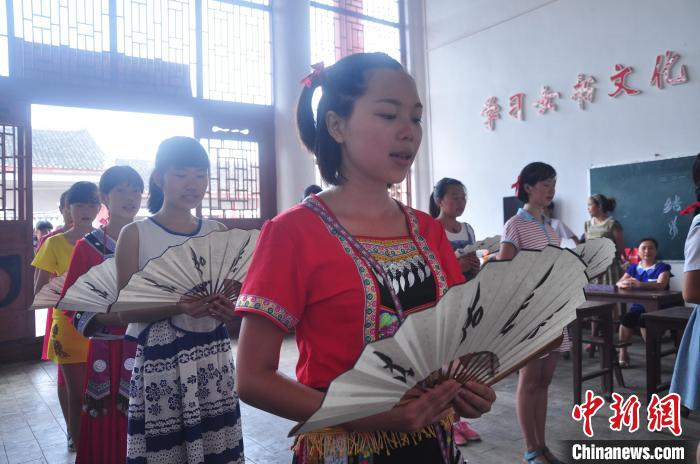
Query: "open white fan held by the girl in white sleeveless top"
110 229 260 311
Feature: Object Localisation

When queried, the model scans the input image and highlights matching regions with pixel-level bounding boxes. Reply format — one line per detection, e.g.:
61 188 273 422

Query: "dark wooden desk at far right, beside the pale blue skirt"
642 306 693 404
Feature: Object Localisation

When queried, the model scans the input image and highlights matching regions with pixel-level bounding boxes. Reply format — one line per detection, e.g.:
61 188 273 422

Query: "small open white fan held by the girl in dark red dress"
56 258 119 313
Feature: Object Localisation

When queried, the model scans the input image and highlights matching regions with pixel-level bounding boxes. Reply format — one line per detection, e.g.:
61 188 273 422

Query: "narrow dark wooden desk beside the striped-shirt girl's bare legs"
570 301 615 404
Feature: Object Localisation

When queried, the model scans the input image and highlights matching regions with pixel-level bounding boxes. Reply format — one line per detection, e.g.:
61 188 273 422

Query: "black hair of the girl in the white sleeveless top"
148 136 209 214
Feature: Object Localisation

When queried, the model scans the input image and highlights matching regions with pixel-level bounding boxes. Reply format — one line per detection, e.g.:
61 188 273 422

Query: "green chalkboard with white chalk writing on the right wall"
591 156 695 260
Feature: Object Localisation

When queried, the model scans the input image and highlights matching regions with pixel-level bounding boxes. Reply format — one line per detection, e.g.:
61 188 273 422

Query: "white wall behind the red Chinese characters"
425 0 700 290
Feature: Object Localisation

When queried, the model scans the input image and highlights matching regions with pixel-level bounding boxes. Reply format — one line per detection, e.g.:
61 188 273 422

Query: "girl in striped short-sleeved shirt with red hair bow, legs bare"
498 162 569 464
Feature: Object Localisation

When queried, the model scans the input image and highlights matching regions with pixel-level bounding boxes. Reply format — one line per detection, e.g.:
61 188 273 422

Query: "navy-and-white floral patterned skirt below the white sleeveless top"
126 320 244 464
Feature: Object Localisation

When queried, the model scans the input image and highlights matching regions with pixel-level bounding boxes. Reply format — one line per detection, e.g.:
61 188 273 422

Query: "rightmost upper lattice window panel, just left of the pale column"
202 0 272 105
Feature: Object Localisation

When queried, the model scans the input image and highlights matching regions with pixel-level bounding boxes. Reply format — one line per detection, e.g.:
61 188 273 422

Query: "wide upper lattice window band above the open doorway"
9 0 272 105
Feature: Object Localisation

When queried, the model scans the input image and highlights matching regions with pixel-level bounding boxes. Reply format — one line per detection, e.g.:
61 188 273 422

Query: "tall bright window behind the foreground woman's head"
310 0 411 205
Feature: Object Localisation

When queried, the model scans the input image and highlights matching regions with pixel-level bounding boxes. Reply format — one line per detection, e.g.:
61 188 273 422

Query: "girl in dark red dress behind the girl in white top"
63 166 144 464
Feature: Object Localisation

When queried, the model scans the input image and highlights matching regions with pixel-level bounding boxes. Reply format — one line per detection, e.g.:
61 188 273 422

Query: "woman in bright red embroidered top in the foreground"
236 53 495 464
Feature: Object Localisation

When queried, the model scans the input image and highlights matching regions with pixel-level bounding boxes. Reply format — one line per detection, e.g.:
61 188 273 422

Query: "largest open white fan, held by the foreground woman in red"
290 246 588 435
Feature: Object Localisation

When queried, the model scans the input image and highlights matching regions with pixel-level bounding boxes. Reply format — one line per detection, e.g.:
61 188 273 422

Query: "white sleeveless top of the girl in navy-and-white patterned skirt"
126 217 221 338
